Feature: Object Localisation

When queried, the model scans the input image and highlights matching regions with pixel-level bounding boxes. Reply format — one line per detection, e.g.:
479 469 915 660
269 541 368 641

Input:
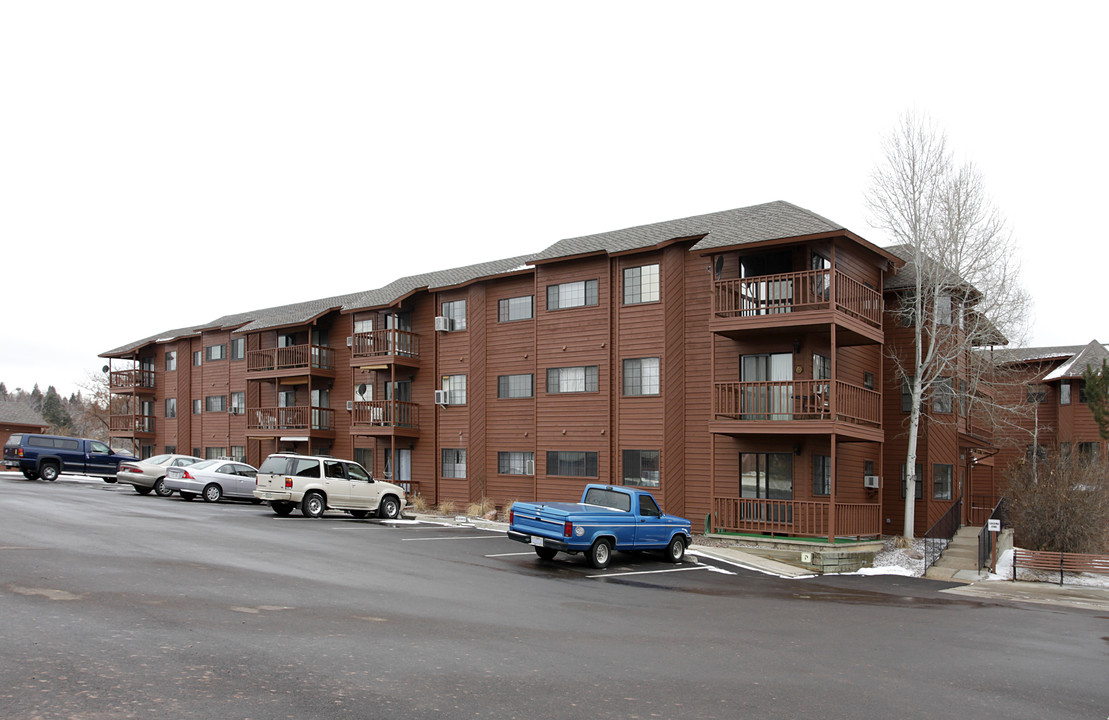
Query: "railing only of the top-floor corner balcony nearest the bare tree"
713 270 882 327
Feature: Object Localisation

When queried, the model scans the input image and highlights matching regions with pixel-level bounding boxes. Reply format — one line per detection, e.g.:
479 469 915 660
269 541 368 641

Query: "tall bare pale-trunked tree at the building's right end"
866 114 1030 538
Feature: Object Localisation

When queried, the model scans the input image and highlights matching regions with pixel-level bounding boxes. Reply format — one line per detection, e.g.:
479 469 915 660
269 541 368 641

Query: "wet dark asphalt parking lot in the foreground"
0 474 1109 719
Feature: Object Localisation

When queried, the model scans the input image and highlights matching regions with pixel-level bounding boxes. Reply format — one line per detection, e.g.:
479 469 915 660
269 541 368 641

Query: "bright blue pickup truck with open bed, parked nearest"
508 485 693 568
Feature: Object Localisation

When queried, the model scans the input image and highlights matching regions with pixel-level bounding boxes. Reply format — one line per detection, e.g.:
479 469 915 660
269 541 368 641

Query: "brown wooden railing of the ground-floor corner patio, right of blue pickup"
712 497 882 538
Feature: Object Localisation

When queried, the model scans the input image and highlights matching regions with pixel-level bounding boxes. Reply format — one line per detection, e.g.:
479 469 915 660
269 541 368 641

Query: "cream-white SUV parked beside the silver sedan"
254 453 406 518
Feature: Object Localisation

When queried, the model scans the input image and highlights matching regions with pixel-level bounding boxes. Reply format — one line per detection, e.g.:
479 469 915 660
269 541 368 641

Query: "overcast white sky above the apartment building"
0 0 1109 393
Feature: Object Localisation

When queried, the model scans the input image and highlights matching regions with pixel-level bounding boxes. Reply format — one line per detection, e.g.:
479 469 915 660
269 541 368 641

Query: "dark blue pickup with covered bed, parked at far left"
3 433 139 483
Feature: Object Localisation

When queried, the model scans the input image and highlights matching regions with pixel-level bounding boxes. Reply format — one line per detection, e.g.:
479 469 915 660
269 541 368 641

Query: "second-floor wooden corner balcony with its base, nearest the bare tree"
710 379 883 442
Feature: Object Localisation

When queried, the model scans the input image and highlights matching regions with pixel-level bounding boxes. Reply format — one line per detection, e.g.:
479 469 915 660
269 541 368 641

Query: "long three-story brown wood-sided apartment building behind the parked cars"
102 202 1029 538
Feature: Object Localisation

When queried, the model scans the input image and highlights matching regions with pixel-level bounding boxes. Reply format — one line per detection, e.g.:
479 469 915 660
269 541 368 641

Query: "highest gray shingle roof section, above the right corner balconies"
535 200 845 261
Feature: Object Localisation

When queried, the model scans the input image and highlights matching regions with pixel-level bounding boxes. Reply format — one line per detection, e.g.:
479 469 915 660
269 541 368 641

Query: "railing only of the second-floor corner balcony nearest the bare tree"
713 379 882 427
